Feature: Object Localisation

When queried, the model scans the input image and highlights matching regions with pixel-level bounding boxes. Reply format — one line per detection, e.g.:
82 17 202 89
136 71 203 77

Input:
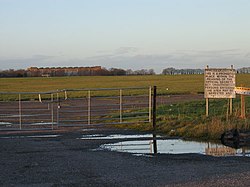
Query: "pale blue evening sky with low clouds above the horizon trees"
0 0 250 73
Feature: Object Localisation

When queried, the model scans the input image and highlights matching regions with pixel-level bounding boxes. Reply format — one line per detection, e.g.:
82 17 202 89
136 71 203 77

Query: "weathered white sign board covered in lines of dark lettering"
204 68 235 98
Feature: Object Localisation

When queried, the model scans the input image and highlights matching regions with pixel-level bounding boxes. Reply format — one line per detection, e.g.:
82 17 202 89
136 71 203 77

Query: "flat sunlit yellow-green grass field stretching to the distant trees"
0 74 250 94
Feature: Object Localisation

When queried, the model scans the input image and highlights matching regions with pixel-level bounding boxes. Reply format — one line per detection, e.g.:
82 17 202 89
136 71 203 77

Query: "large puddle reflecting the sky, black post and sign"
93 135 250 156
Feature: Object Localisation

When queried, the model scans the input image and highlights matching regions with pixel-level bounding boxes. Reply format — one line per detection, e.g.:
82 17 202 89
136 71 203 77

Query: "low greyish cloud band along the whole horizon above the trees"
0 47 250 73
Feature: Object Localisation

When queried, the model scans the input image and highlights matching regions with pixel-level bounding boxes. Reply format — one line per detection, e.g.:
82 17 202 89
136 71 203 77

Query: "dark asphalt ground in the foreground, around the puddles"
0 127 250 187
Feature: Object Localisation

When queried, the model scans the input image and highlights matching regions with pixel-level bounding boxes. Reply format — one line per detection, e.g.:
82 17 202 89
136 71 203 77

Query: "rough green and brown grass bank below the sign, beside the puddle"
116 97 250 140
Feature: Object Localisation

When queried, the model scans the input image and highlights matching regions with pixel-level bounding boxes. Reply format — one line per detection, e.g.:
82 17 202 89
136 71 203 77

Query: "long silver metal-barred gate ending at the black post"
0 87 152 131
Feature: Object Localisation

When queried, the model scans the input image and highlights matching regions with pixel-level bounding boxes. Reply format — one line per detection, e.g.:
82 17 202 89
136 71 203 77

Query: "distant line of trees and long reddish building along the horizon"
0 66 250 77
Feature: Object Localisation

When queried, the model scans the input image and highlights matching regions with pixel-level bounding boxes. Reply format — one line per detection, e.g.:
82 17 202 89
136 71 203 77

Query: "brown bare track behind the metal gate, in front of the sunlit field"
0 95 203 133
